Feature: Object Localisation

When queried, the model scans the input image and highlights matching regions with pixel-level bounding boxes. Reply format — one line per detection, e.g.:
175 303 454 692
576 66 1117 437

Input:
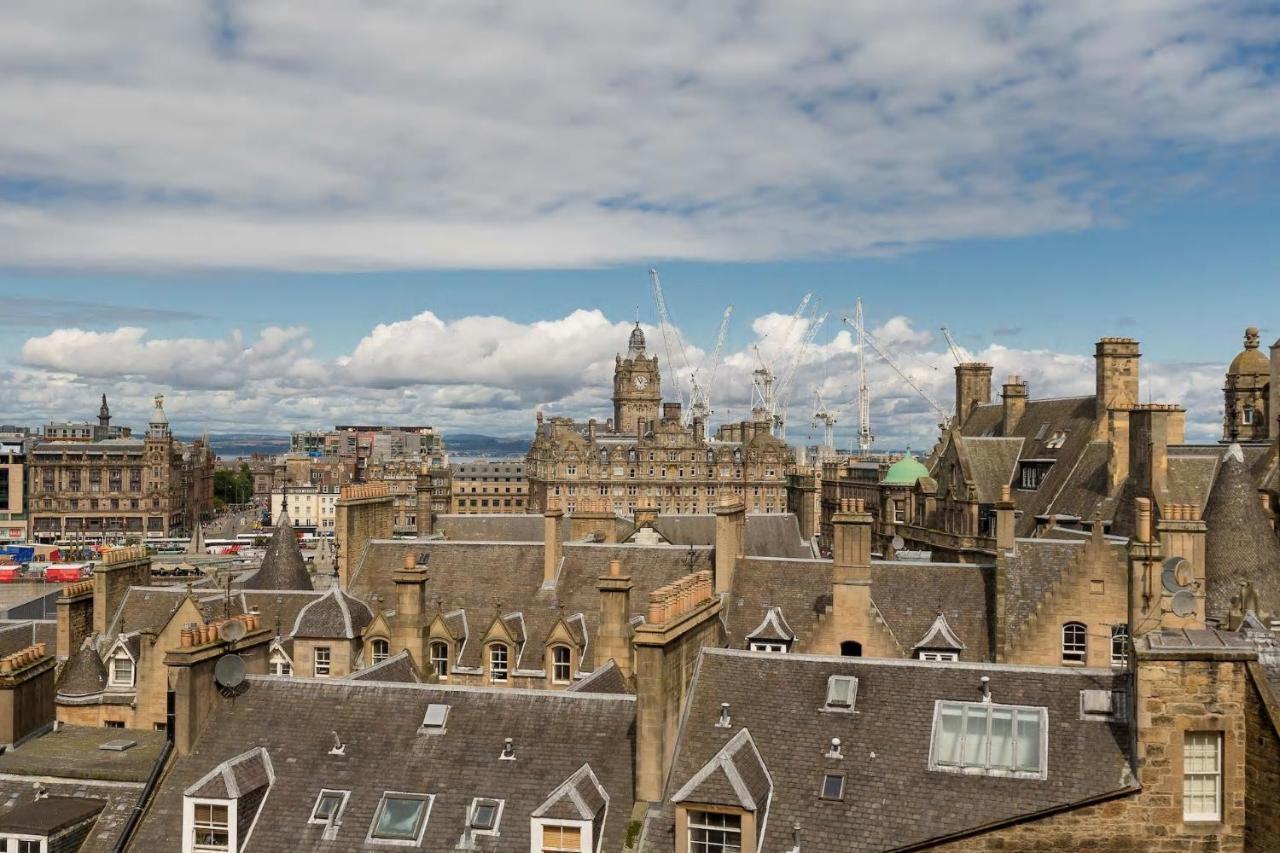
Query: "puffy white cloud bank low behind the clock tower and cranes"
0 302 1233 448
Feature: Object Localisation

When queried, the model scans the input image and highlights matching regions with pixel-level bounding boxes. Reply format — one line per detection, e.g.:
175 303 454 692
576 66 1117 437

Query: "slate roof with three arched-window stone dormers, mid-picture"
351 539 713 672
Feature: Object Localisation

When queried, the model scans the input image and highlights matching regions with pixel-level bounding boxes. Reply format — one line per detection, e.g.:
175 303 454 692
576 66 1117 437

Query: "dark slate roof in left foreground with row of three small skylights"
127 676 635 853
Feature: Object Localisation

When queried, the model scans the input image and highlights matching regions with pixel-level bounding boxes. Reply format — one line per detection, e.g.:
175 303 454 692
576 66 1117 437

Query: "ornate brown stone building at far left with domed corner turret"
28 396 214 542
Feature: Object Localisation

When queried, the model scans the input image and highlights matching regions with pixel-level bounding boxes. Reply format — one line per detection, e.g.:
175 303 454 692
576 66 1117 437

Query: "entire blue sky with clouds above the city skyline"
0 0 1280 447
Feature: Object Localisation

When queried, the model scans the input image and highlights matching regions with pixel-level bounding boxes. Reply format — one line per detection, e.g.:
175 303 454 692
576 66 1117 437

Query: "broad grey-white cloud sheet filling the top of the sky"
0 0 1280 269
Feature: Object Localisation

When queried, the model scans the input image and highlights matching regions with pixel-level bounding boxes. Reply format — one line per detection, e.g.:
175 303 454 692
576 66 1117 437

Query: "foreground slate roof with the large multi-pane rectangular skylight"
643 649 1135 852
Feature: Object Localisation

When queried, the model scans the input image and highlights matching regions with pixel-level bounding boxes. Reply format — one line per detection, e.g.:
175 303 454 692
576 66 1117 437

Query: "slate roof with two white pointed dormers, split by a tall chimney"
724 558 996 661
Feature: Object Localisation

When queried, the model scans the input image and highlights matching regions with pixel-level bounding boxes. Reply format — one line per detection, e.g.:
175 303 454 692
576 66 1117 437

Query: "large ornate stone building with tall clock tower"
526 324 795 515
